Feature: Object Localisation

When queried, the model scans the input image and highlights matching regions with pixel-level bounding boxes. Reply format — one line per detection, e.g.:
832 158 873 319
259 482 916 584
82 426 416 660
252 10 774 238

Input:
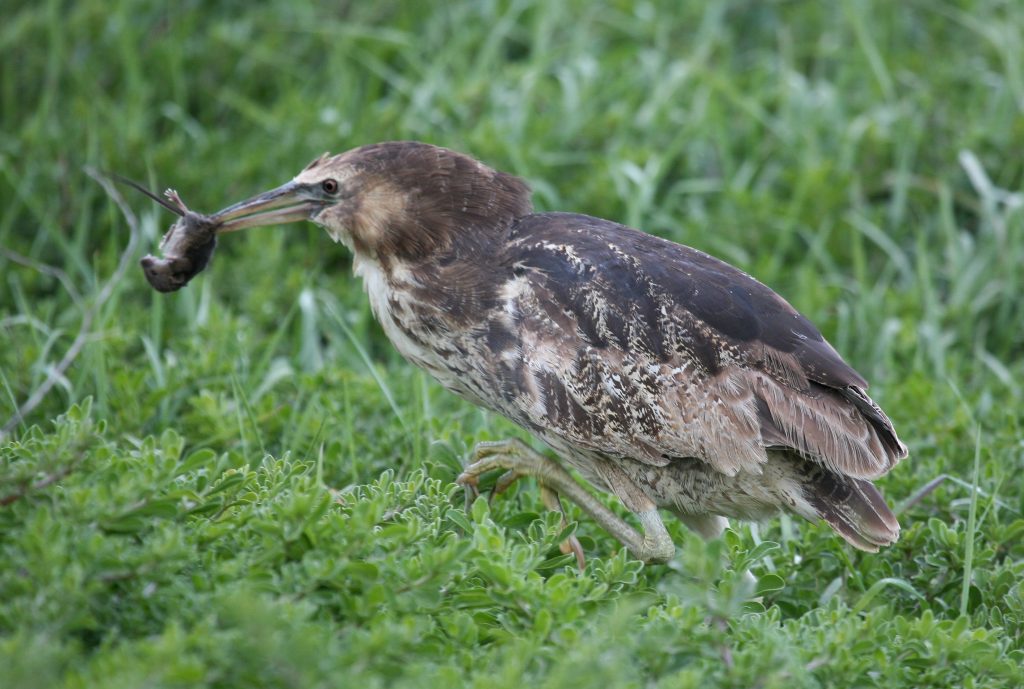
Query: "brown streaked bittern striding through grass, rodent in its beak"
172 141 907 562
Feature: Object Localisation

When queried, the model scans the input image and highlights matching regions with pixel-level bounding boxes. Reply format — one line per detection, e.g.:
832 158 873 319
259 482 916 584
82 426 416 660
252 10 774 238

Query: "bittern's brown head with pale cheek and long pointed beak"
214 141 530 261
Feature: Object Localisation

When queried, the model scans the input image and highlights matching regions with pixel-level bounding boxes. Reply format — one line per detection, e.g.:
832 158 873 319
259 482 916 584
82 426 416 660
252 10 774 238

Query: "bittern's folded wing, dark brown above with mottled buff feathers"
481 213 906 478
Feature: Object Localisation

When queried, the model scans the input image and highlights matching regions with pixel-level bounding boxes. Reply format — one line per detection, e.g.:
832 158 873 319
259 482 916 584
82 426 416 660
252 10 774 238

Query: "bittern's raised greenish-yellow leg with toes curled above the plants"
458 439 675 562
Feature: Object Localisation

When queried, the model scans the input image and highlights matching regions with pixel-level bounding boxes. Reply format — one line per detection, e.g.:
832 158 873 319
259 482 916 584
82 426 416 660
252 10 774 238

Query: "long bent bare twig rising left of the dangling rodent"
0 167 141 438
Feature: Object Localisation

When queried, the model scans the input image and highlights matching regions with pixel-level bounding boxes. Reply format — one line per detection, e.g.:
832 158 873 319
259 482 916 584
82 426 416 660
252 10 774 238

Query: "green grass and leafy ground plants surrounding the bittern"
0 0 1024 689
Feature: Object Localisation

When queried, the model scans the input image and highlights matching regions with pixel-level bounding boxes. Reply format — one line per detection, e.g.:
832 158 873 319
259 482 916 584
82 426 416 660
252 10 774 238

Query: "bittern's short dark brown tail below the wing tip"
803 469 899 553
